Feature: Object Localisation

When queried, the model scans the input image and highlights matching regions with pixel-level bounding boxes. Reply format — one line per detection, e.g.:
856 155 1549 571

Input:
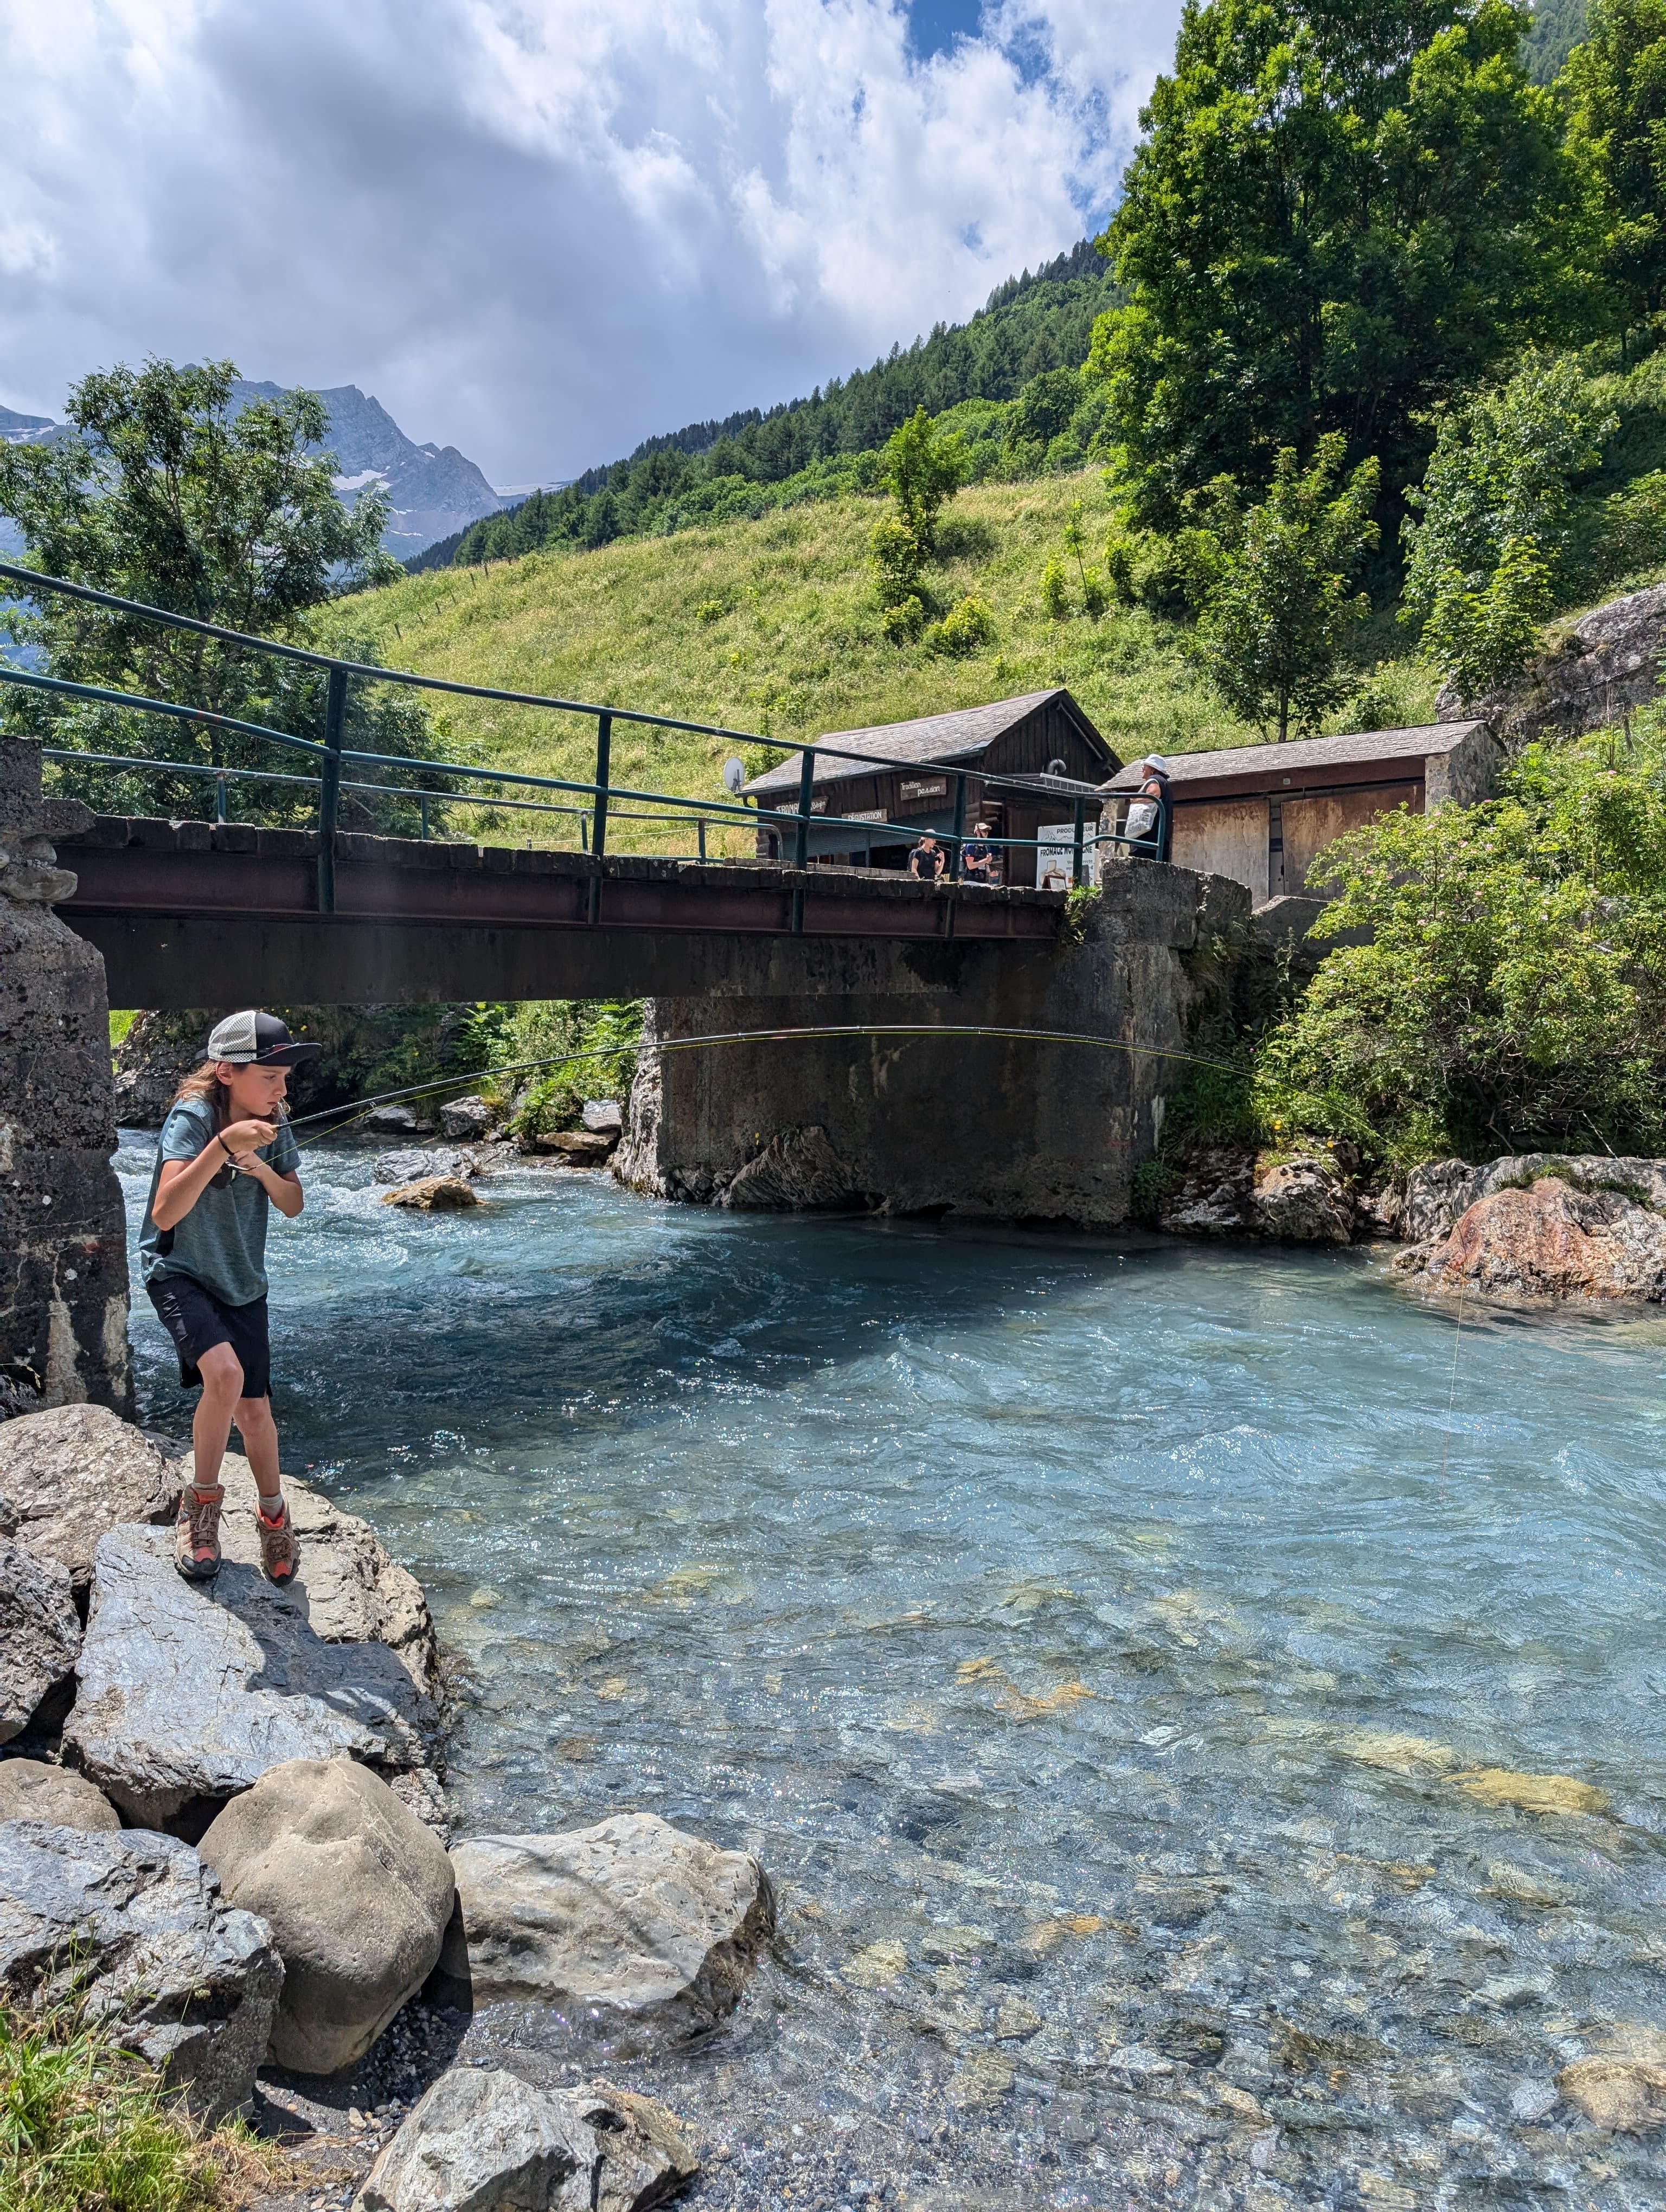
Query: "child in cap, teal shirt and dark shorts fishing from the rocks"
139 1008 321 1584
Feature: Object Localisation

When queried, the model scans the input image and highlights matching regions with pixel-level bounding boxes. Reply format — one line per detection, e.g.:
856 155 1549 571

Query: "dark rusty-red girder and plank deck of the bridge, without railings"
57 816 1064 1006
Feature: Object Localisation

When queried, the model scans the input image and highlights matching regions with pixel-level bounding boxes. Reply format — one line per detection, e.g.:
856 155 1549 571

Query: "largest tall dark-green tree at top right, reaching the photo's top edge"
1088 0 1566 529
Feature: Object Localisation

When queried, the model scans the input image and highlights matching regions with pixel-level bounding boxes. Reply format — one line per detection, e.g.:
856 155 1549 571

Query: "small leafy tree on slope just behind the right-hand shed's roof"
1197 432 1379 741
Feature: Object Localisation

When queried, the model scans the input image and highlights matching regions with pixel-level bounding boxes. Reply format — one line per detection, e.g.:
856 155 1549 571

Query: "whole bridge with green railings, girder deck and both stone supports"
0 562 1248 1405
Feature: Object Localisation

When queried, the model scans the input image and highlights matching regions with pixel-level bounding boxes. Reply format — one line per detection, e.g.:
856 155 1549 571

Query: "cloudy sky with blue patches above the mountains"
0 0 1179 485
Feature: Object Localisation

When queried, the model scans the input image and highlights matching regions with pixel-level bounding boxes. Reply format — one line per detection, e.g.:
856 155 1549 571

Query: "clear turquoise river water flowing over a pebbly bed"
117 1139 1666 2212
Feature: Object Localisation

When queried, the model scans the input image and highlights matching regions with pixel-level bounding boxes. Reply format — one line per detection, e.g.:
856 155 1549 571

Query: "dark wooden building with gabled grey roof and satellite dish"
746 690 1122 883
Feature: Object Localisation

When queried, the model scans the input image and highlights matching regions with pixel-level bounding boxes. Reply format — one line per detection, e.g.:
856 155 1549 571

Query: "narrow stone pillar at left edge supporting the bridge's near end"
0 739 133 1411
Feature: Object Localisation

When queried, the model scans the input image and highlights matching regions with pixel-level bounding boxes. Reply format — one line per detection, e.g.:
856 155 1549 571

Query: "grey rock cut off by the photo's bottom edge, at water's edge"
354 2066 699 2212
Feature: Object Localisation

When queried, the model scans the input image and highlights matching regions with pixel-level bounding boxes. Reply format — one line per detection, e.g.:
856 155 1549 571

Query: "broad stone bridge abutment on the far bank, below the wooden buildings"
613 865 1250 1227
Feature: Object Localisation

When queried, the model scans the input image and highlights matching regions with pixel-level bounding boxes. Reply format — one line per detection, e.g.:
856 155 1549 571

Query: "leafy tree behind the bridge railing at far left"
0 361 449 832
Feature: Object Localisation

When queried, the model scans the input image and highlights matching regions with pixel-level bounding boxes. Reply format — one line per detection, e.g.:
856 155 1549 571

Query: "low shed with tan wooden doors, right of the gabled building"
1104 721 1498 907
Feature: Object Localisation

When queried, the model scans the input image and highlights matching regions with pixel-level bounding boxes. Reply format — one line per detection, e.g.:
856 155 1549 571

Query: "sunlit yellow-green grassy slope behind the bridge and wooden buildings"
338 469 1432 852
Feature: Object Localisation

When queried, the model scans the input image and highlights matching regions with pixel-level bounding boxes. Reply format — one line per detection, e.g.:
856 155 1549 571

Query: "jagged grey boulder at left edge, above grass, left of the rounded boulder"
0 1821 283 2119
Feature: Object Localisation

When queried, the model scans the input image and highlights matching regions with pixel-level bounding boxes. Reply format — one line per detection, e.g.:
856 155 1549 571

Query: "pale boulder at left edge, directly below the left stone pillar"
0 1405 179 1595
